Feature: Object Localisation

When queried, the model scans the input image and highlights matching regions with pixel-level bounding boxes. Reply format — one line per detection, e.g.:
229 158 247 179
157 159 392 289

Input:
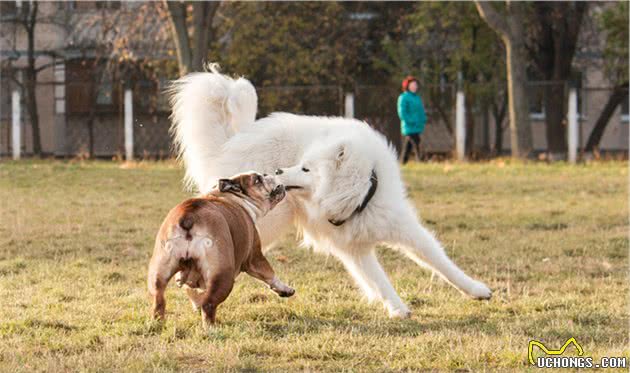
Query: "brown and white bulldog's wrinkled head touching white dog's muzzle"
218 172 286 214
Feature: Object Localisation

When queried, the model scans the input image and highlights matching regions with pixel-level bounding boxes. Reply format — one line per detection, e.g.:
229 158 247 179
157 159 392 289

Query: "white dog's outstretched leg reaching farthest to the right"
390 209 492 299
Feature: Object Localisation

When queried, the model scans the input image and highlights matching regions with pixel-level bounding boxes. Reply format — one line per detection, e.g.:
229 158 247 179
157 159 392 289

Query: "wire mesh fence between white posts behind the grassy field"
0 79 628 158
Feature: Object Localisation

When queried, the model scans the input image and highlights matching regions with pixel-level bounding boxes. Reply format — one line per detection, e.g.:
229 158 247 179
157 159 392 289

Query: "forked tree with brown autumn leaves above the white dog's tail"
76 1 221 75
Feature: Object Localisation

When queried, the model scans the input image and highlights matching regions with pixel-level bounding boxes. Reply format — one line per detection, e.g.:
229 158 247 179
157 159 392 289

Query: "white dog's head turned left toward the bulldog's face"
276 140 374 220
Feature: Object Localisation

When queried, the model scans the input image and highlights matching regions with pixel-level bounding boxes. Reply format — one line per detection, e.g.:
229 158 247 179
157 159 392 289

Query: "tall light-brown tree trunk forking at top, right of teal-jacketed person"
475 1 533 158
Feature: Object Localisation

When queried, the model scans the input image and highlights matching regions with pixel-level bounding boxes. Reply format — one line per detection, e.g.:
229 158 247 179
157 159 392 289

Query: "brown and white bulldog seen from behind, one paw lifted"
148 172 295 325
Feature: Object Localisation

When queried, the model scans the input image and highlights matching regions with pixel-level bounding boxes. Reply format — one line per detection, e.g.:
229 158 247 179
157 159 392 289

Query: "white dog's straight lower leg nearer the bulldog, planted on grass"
334 251 411 318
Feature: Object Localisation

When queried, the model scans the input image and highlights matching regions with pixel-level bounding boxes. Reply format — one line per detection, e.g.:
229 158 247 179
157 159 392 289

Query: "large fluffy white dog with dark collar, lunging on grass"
171 66 492 317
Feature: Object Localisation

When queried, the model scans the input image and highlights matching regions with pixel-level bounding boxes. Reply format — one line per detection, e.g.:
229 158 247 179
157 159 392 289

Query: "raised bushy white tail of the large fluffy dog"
168 64 258 191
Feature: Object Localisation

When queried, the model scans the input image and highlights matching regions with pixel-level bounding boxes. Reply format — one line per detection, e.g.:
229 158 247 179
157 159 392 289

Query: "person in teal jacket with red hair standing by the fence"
398 76 427 164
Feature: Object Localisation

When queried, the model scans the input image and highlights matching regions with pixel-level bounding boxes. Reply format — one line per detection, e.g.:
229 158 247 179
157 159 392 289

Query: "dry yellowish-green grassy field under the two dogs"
0 161 630 372
